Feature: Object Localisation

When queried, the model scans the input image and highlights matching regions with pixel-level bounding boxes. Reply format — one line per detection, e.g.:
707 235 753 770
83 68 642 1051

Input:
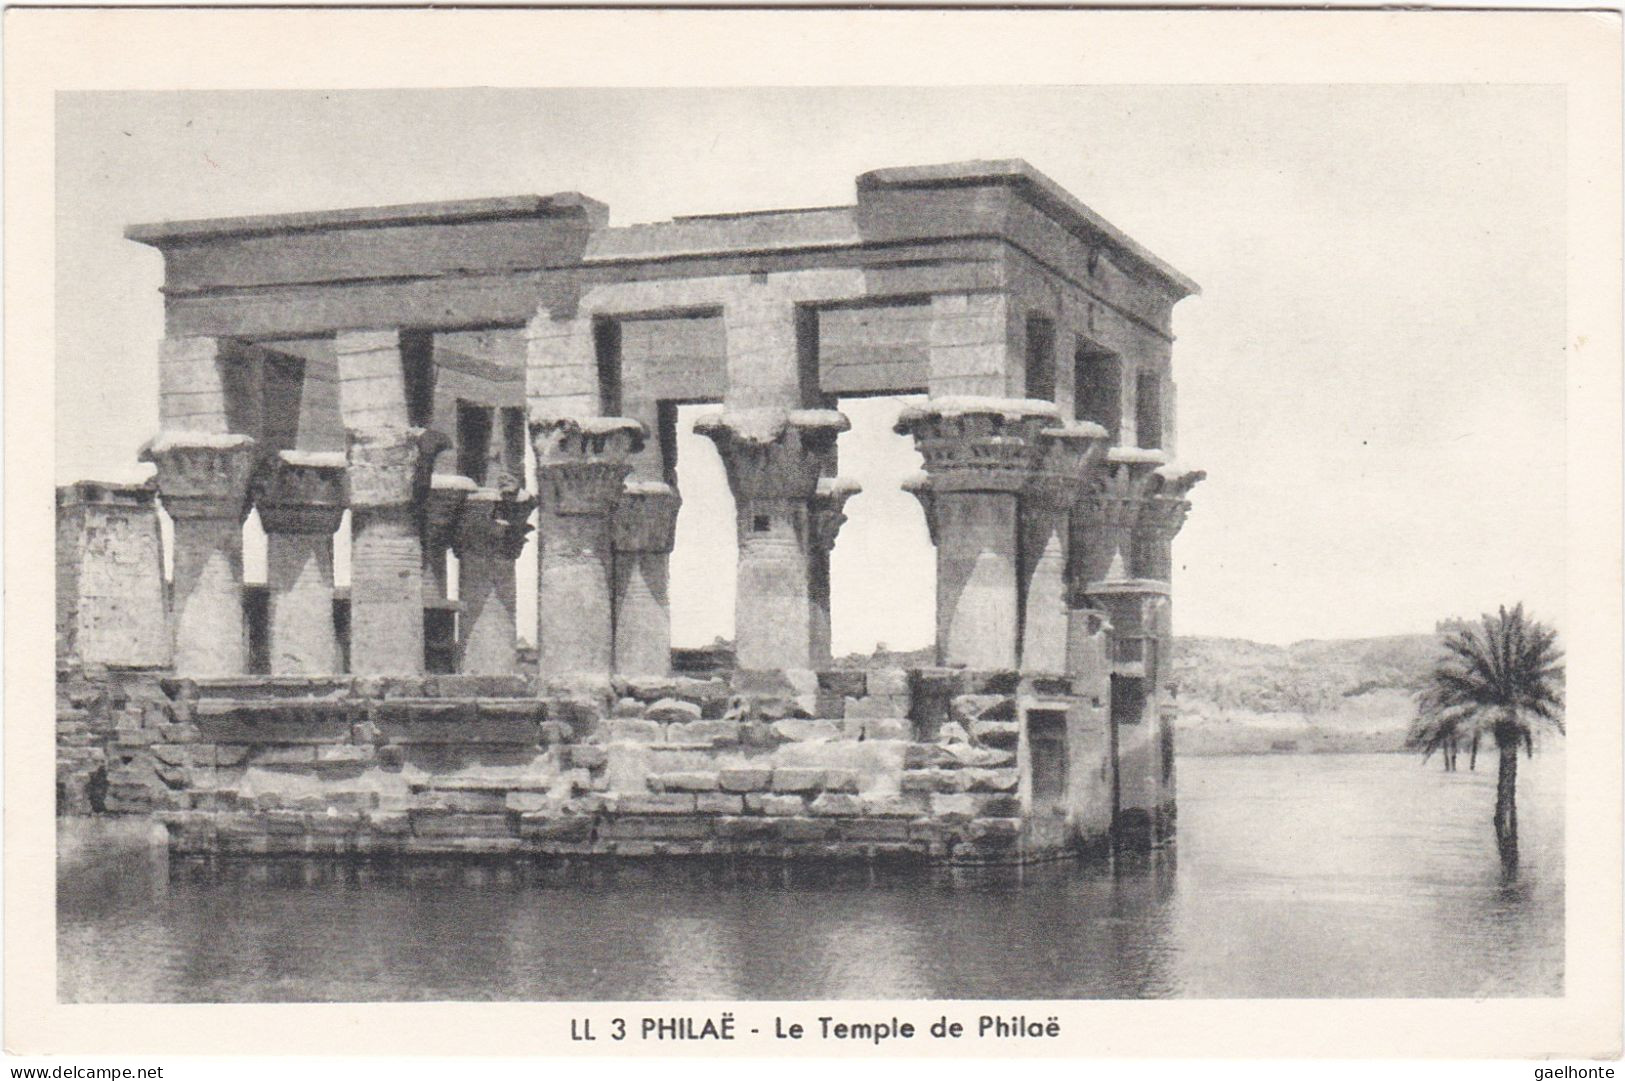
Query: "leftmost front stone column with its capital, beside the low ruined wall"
141 432 255 676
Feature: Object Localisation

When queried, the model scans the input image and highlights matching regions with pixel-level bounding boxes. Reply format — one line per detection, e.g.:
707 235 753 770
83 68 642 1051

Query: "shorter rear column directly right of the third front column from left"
614 481 683 676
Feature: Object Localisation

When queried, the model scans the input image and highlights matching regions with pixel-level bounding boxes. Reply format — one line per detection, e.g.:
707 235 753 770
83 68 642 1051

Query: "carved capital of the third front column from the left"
530 416 645 514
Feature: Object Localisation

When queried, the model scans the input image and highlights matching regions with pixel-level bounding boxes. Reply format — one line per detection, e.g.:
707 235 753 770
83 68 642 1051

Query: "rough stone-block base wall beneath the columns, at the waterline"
59 670 1137 863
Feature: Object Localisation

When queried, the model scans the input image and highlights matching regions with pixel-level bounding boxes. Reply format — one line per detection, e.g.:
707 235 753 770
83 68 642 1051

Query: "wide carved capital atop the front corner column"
894 397 1060 493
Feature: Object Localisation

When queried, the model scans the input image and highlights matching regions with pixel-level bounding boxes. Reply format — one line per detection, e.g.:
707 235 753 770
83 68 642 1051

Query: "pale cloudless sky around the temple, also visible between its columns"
54 86 1565 652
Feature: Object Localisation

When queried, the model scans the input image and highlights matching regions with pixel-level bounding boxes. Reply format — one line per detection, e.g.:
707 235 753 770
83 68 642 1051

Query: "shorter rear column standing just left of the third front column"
452 488 536 676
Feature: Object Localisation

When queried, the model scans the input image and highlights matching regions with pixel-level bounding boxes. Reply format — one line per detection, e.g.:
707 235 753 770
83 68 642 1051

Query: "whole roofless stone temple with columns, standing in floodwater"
57 161 1201 863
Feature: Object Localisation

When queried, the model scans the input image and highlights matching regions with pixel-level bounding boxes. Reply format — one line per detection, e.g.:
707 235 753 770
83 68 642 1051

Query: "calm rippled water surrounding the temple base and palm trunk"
59 754 1563 1001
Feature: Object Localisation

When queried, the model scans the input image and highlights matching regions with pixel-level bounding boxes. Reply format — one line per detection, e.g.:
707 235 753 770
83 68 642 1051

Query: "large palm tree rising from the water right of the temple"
1412 605 1563 862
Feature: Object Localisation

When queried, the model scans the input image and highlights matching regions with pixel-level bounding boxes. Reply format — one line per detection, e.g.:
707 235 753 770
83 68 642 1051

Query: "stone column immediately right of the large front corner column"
1019 421 1107 675
